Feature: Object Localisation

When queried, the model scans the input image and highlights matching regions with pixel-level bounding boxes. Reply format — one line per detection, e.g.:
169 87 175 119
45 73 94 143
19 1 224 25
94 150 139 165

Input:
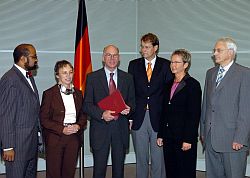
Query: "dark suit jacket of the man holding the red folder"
83 68 135 149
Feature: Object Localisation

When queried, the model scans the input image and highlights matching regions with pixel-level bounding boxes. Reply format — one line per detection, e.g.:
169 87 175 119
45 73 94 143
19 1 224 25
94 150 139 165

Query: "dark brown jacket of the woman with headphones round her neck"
40 84 87 145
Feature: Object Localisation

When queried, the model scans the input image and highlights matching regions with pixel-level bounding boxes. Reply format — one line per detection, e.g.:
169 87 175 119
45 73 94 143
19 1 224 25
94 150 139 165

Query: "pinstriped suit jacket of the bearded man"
0 66 40 163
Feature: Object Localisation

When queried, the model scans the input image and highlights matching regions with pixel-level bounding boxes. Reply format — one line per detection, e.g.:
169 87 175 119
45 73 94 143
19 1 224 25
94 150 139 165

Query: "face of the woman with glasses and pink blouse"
170 55 188 75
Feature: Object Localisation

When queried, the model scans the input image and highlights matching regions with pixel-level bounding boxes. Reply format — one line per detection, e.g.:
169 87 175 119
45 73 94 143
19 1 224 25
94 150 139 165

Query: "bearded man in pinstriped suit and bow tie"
0 44 40 178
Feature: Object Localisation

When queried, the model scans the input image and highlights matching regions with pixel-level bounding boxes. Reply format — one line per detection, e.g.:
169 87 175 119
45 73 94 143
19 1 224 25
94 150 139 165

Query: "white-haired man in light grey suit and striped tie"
200 38 250 178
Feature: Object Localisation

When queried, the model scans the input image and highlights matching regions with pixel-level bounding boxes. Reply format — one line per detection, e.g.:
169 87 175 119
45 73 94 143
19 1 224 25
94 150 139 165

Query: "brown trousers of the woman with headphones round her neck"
45 134 80 178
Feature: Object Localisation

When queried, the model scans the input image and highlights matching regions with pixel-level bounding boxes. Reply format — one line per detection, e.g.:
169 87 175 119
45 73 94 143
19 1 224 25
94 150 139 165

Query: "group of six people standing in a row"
0 33 250 178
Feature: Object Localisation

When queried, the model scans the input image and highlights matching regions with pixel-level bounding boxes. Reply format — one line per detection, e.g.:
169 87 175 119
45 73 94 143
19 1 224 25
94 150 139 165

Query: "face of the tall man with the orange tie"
141 41 158 61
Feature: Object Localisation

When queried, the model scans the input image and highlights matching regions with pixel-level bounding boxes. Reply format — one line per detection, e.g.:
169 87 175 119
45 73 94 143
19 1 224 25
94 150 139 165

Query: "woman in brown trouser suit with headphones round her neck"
40 60 87 178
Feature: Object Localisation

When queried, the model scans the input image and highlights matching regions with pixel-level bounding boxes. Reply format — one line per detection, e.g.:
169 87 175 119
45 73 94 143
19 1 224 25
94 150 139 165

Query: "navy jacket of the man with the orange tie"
128 57 173 132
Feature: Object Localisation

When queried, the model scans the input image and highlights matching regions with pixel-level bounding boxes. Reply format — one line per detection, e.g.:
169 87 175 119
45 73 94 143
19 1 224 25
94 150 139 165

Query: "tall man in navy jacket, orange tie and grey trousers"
128 33 173 178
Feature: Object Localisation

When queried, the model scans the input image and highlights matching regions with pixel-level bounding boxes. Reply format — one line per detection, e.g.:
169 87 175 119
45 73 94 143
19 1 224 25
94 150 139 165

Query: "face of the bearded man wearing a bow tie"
24 46 38 70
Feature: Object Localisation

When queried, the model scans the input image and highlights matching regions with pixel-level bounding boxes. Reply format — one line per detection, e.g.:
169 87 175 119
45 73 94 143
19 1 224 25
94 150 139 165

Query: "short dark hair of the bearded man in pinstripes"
13 44 34 64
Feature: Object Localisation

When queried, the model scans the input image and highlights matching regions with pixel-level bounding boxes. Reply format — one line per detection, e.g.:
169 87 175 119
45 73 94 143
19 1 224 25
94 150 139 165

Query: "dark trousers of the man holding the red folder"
92 121 126 178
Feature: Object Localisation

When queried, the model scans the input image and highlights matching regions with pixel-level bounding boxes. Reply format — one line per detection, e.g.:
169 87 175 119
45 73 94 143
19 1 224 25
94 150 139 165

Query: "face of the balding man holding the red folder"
102 46 120 71
